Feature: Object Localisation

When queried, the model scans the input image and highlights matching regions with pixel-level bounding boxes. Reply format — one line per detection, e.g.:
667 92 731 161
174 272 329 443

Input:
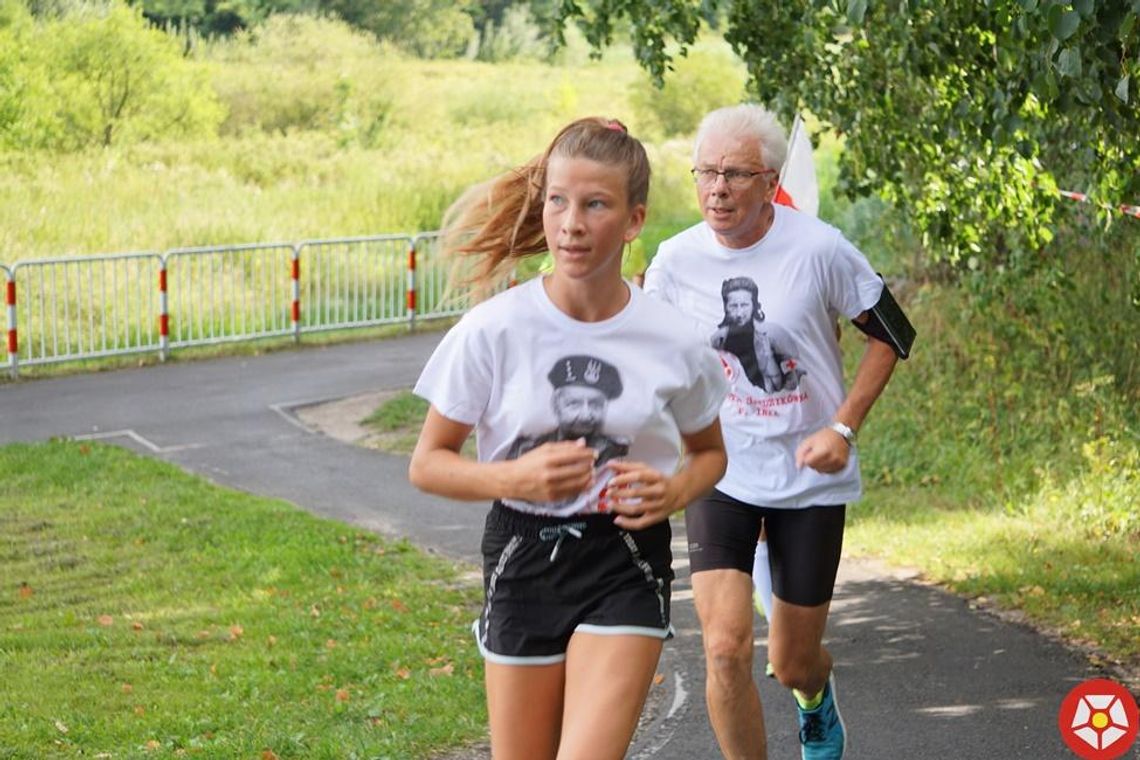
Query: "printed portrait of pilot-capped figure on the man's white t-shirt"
710 277 806 393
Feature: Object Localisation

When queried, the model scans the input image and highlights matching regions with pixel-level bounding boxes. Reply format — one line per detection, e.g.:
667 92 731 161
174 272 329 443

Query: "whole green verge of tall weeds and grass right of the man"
845 268 1140 683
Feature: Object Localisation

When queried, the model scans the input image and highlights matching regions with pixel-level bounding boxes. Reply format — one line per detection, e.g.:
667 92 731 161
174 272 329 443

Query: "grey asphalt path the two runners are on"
0 332 1140 760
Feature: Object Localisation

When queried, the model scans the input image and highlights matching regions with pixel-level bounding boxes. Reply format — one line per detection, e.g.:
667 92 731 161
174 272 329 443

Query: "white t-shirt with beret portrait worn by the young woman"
415 277 727 516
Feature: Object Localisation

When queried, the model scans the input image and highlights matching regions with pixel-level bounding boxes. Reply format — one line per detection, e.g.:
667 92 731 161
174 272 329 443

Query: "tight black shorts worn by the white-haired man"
685 490 847 607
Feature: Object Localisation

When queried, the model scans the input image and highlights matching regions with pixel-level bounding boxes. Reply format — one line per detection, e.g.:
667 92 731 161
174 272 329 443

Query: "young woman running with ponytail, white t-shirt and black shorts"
409 119 726 760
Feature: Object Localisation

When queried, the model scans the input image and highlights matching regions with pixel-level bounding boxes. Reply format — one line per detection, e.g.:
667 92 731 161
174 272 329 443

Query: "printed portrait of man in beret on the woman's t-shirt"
506 354 629 509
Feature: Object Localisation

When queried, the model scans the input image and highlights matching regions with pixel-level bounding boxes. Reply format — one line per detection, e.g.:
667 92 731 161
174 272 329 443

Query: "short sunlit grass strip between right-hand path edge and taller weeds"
845 468 1140 676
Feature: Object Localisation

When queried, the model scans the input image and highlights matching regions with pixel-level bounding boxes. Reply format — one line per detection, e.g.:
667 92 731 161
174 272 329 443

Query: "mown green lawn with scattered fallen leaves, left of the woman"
0 441 485 758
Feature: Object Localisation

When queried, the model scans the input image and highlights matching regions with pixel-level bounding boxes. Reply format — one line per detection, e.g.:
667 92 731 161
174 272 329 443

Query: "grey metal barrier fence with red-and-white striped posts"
0 232 467 377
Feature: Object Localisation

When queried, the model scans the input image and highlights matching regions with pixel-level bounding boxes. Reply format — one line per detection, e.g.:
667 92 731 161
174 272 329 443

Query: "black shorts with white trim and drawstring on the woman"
474 502 673 664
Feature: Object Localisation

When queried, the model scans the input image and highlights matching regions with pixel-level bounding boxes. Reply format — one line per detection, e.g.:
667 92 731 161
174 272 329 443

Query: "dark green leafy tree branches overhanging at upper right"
555 0 1140 273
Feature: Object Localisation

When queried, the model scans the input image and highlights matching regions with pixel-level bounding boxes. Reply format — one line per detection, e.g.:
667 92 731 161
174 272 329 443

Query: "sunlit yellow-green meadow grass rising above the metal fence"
0 50 661 265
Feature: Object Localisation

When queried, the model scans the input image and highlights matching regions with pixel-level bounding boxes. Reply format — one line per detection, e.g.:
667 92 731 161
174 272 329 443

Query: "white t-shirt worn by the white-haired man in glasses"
645 205 882 508
